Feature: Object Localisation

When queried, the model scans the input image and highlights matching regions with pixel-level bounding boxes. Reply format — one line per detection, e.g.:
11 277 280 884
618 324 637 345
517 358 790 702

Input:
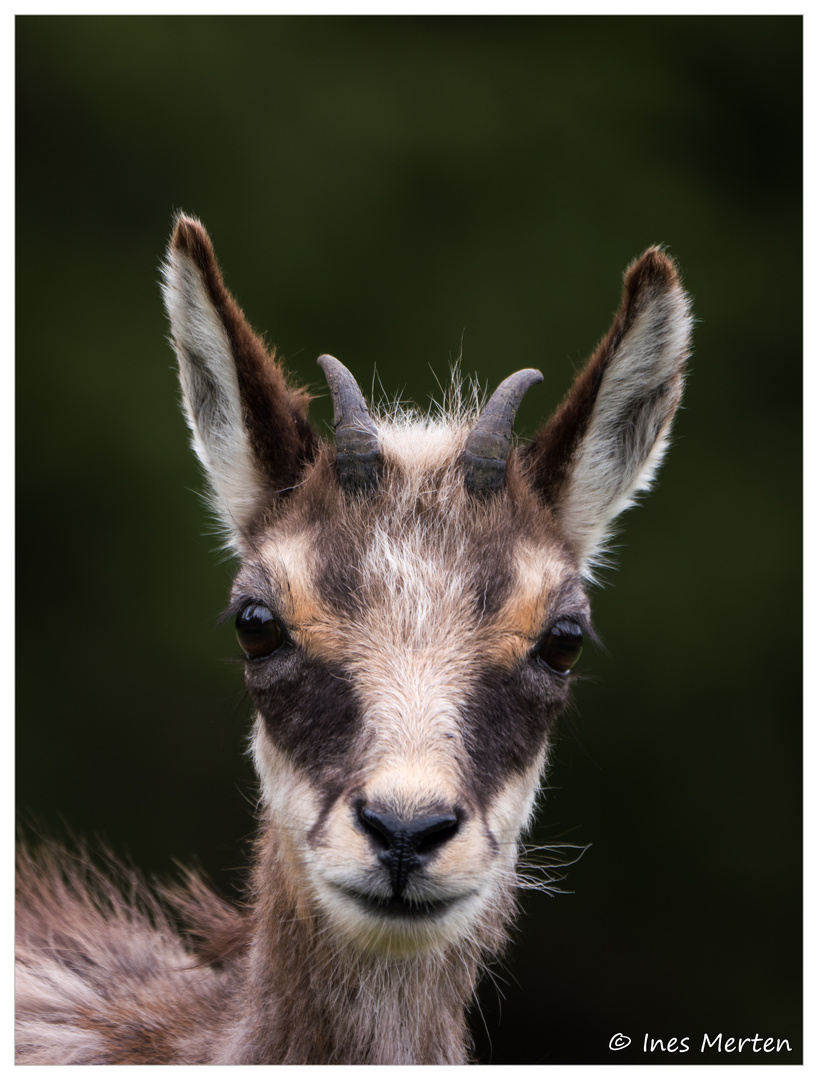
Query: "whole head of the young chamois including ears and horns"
164 216 690 957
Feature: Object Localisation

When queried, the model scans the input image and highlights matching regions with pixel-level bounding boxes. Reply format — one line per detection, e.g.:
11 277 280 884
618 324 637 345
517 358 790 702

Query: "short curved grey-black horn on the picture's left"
318 355 380 490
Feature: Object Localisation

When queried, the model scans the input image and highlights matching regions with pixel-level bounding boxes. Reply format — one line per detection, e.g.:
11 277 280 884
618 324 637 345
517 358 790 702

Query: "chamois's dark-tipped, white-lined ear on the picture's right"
523 247 693 576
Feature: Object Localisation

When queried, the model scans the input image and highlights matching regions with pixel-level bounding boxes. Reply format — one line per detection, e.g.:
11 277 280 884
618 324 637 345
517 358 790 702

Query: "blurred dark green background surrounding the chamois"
16 16 802 1064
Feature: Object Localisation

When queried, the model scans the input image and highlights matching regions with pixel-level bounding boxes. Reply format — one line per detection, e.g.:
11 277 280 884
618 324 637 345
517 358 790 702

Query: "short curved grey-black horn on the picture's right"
462 367 542 495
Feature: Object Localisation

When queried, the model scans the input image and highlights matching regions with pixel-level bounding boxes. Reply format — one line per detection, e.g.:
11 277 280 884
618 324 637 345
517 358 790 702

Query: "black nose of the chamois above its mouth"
358 804 460 896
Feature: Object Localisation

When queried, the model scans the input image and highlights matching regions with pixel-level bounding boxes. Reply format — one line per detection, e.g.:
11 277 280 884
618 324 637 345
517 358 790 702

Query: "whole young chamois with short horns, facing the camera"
17 215 692 1064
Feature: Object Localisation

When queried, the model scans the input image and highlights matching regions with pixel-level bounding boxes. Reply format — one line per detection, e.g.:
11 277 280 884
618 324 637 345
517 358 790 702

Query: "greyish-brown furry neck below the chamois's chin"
213 825 494 1065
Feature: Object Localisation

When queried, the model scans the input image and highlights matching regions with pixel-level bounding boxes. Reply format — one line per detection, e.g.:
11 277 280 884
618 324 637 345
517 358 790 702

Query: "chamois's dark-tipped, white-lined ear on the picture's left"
162 214 317 550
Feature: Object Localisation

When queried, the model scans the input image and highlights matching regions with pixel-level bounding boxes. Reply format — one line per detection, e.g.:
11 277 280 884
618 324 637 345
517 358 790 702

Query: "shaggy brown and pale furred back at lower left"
16 850 241 1065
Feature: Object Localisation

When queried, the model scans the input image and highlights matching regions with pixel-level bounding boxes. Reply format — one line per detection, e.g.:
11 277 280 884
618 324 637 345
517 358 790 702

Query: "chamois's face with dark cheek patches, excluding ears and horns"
231 422 588 950
